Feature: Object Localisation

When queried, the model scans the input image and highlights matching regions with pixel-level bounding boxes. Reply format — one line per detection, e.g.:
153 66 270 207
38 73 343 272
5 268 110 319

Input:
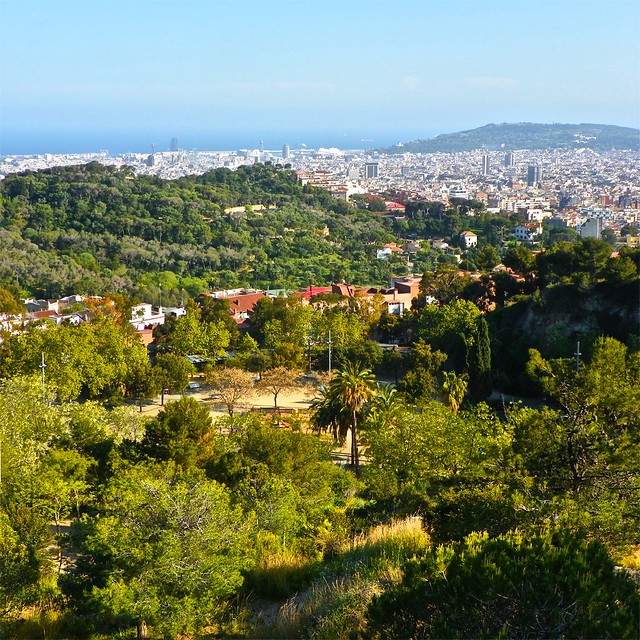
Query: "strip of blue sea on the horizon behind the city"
0 129 435 156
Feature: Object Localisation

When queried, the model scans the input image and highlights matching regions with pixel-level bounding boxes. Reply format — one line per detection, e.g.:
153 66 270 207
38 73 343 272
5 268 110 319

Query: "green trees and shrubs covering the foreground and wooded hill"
0 165 640 638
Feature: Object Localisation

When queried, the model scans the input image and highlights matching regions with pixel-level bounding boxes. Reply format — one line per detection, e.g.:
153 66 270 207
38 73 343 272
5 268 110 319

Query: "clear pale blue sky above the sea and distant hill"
0 0 640 153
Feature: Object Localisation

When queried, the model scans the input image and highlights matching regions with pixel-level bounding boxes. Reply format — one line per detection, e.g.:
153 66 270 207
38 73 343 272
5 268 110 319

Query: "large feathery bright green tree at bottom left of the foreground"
74 465 252 638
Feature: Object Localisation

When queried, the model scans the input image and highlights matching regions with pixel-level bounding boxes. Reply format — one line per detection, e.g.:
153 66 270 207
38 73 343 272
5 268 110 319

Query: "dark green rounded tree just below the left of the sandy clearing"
141 396 213 468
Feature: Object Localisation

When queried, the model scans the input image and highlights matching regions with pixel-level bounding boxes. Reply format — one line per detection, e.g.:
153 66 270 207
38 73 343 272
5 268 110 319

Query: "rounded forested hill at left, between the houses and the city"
0 163 393 304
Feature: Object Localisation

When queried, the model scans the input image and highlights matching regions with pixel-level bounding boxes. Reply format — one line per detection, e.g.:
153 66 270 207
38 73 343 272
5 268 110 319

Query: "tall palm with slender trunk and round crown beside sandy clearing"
329 362 375 475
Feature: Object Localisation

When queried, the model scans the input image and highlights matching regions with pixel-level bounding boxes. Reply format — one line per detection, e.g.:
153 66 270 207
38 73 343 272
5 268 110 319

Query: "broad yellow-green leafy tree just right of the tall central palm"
362 399 513 516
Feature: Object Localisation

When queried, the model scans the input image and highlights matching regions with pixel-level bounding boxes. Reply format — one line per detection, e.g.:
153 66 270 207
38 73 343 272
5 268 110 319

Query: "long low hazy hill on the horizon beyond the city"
382 122 640 153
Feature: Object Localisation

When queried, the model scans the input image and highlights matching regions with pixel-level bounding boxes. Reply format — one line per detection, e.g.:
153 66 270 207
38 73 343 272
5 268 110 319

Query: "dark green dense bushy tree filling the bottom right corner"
365 531 640 638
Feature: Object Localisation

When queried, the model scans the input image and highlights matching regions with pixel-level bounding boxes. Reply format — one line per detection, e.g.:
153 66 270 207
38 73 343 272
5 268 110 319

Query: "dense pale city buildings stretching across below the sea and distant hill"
0 137 640 246
